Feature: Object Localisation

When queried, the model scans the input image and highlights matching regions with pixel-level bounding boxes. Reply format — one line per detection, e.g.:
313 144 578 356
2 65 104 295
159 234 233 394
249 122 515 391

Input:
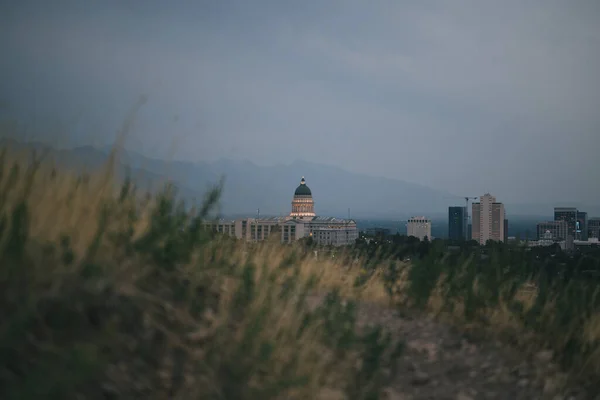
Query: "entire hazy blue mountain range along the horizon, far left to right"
4 140 596 219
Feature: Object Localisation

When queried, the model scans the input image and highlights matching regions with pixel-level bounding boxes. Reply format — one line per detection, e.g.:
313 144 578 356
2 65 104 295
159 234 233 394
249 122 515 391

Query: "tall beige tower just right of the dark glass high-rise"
471 193 505 245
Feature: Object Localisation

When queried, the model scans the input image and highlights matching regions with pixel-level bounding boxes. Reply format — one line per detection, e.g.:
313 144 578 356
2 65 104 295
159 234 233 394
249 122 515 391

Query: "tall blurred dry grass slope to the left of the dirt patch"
0 145 401 399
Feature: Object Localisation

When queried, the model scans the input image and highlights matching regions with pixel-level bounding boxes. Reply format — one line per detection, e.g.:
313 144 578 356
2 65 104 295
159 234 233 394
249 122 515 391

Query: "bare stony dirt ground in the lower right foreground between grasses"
311 296 600 400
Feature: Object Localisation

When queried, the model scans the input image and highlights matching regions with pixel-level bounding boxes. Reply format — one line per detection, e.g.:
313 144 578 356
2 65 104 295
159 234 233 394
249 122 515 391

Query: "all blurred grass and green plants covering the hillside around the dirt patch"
0 140 600 400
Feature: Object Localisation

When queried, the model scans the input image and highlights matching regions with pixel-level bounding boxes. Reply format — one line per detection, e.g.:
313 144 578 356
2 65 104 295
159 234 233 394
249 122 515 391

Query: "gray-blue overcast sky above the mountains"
0 0 600 204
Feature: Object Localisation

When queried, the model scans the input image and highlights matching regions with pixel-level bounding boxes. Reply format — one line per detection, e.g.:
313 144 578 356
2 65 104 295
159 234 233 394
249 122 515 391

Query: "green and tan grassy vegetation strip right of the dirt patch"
375 243 600 390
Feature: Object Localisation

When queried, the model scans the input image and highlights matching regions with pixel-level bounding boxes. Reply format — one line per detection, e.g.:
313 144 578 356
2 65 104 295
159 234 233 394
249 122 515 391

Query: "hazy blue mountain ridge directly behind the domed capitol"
118 148 460 217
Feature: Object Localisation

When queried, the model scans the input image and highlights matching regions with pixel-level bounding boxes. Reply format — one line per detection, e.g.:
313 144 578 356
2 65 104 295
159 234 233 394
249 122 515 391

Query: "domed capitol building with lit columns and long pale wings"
205 177 358 246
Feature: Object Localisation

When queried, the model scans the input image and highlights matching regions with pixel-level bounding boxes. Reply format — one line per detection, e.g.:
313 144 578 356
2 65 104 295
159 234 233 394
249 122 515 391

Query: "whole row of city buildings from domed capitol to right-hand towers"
218 176 600 244
